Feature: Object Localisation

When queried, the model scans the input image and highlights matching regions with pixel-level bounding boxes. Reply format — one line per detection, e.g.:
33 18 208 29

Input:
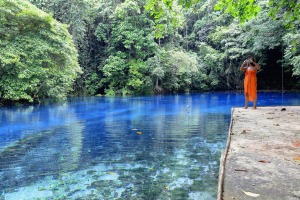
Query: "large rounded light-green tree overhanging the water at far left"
0 0 81 102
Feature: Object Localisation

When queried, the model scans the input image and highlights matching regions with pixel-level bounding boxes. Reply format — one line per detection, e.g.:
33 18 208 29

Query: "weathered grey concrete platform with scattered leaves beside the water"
218 106 300 200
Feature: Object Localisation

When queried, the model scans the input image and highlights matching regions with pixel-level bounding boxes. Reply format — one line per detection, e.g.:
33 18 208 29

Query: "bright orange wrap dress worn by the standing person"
244 70 257 101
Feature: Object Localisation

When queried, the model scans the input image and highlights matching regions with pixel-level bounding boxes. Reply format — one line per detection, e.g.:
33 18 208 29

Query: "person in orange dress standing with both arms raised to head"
240 57 260 109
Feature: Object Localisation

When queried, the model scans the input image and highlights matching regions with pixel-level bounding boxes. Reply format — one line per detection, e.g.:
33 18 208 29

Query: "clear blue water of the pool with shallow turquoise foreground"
0 93 300 200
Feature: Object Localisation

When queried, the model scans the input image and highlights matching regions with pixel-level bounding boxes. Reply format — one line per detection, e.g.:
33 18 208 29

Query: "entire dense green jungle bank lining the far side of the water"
0 0 300 105
